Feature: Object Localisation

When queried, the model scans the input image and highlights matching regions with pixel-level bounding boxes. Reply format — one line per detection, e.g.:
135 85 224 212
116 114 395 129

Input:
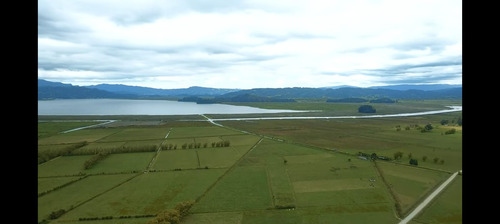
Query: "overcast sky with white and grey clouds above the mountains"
38 0 462 89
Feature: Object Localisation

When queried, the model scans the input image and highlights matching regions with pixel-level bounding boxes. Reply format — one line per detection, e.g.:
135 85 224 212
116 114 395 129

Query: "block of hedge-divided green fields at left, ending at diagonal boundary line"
38 122 265 223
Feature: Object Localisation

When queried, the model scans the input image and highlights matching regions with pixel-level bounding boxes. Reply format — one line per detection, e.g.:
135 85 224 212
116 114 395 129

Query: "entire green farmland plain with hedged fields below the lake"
38 102 462 224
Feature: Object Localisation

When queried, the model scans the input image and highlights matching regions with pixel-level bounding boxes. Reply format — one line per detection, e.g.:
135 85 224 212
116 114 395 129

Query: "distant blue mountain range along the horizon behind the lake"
38 79 462 102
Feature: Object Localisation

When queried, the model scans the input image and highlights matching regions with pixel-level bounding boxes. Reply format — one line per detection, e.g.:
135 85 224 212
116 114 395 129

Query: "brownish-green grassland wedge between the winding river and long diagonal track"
219 112 462 171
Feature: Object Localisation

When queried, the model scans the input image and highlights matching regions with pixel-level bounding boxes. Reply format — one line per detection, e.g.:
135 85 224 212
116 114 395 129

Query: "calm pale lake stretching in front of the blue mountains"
38 99 300 115
